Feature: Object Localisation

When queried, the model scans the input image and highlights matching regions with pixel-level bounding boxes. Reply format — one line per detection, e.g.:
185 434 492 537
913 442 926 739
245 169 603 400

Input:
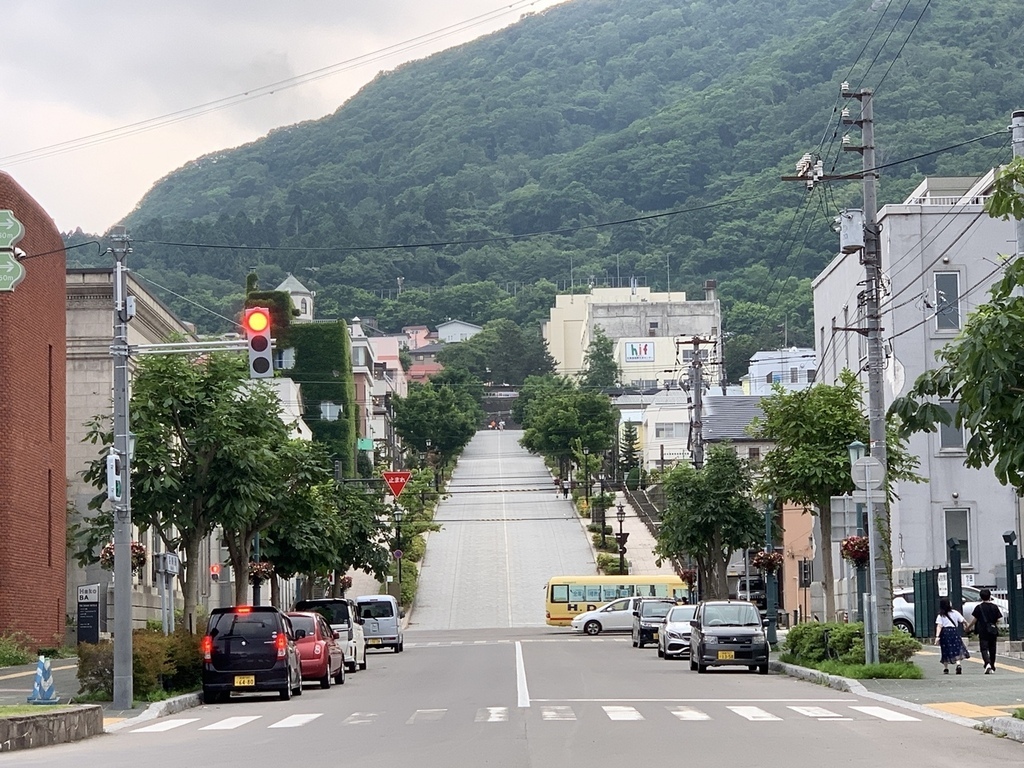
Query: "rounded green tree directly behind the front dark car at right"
654 444 764 599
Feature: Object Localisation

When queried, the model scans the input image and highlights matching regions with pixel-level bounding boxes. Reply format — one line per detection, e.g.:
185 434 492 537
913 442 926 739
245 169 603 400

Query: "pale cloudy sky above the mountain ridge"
0 0 569 233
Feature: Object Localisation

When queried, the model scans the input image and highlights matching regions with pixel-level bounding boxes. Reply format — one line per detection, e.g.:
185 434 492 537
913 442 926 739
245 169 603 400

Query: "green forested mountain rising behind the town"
61 0 1024 372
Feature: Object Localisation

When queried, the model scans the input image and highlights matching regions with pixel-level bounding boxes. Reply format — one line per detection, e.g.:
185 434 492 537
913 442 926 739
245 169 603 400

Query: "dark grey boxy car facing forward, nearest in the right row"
690 600 769 675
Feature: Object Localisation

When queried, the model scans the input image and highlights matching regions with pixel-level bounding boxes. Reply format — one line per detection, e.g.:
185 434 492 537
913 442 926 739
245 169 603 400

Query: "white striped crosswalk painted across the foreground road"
129 702 920 733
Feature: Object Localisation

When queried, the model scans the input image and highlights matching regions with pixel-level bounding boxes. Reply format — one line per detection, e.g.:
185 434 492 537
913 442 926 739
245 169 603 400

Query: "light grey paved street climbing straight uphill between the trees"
411 430 595 630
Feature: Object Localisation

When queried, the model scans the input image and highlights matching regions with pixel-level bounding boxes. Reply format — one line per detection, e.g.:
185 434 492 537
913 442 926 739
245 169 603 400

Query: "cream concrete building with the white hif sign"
543 281 722 388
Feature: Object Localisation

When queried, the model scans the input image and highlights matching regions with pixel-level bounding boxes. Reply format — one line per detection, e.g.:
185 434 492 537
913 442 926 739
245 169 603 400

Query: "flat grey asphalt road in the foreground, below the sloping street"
0 628 1021 768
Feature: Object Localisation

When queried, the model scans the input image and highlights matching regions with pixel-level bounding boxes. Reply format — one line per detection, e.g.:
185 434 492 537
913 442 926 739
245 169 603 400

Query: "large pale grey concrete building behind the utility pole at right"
813 172 1024 587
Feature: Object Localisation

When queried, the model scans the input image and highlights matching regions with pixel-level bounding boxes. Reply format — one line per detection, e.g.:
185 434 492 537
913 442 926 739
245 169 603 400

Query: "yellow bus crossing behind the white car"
545 575 690 627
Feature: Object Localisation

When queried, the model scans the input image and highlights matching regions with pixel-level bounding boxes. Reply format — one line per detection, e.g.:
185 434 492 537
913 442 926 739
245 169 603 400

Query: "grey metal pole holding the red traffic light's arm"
108 226 135 710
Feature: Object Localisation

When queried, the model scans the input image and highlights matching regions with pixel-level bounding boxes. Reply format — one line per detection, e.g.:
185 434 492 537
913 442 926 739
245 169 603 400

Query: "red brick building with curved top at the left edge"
0 172 68 645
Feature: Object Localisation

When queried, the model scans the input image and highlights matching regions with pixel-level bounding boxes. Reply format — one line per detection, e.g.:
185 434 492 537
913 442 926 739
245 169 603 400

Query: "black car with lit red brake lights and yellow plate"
200 605 302 703
